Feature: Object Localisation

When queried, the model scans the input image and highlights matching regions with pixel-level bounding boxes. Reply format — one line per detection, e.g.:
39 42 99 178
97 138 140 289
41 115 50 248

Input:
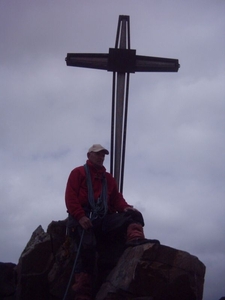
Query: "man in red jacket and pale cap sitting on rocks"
65 144 145 300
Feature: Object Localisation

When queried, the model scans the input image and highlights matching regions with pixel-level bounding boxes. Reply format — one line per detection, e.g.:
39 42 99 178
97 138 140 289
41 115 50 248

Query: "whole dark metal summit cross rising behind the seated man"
66 16 180 193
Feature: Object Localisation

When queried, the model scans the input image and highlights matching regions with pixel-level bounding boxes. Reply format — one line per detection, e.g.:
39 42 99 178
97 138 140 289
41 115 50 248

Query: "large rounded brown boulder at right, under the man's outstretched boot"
96 243 205 300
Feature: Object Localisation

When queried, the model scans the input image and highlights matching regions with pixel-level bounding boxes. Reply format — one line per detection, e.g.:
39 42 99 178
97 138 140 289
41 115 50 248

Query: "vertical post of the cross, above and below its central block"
110 16 130 192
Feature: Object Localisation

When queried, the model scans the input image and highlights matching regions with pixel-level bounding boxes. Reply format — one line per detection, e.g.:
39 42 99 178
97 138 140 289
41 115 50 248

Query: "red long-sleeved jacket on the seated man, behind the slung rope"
65 160 131 220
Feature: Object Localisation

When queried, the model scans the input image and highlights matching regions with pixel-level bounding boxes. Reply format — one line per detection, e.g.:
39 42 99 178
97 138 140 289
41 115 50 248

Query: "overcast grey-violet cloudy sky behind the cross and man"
0 0 225 300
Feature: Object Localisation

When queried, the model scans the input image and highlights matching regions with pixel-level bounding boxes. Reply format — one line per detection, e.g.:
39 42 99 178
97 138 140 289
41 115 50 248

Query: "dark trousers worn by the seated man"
68 210 144 274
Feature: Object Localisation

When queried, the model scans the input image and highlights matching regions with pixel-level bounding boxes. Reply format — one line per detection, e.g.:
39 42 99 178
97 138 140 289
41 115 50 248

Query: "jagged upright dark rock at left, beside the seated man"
16 221 69 300
